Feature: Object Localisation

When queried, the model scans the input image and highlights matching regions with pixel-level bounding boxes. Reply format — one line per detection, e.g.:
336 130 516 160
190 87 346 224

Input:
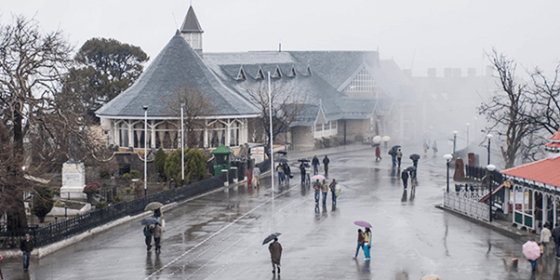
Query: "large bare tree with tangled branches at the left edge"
0 16 101 230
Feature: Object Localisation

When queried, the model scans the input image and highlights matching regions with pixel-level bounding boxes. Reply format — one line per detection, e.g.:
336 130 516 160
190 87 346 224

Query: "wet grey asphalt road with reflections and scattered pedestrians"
2 148 560 280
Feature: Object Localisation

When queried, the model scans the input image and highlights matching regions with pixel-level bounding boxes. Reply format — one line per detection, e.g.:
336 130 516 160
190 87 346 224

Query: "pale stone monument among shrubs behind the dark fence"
60 139 87 199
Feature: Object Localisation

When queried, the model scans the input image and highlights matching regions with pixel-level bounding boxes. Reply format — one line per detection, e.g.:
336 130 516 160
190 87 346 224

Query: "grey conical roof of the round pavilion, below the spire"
96 35 259 118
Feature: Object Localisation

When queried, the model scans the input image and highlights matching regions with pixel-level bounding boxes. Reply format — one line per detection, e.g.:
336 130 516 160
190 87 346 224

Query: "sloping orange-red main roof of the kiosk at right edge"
502 157 560 188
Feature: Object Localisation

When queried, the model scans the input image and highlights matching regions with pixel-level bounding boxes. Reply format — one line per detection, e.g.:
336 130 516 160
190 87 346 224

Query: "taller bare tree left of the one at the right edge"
478 50 536 168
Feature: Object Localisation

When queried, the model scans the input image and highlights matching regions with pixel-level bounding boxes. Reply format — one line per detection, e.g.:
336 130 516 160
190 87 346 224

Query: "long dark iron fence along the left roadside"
0 176 224 249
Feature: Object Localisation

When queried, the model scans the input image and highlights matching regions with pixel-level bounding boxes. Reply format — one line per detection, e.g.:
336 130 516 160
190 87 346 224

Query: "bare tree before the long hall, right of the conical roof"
244 80 306 152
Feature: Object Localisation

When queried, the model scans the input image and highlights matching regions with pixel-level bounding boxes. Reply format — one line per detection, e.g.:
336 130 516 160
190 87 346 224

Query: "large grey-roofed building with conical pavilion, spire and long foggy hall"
96 6 415 152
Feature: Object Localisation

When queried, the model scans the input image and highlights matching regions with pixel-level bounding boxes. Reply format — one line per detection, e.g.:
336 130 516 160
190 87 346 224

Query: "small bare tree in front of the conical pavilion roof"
163 85 215 147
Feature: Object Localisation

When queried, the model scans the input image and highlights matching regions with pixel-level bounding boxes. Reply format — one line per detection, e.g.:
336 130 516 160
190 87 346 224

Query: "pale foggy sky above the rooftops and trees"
0 0 560 76
